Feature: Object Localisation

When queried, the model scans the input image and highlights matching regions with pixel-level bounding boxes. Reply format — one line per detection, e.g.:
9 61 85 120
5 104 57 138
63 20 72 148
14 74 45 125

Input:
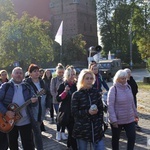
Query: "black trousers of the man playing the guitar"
8 124 34 150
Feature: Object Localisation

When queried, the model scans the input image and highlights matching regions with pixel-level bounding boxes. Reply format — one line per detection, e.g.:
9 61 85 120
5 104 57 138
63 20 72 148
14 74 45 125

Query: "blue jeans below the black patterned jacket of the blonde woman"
77 139 105 150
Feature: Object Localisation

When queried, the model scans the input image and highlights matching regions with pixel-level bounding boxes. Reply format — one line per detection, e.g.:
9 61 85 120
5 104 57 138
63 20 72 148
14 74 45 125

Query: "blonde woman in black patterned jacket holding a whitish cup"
71 69 104 150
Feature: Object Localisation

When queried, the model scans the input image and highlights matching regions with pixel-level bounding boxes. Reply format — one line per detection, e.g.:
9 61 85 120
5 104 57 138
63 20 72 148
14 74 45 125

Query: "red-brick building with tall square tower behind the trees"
12 0 98 47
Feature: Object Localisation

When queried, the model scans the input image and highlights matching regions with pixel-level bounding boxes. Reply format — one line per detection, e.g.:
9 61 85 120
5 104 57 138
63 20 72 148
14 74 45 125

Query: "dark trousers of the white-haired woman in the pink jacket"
111 122 136 150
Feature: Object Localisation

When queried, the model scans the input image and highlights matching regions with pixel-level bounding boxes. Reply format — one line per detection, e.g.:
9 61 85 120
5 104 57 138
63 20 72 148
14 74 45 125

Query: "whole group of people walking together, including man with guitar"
0 62 138 150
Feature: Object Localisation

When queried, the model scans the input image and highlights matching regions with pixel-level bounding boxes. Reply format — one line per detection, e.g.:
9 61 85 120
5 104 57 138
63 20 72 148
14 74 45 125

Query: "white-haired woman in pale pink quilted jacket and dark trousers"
107 70 138 150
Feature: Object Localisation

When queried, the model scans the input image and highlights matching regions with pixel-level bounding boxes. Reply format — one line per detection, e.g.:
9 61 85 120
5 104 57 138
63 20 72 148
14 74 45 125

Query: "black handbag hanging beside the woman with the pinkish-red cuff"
57 112 70 126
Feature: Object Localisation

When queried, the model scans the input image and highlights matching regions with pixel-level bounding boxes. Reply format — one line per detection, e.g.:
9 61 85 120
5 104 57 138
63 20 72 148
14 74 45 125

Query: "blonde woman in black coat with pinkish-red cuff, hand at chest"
56 67 77 150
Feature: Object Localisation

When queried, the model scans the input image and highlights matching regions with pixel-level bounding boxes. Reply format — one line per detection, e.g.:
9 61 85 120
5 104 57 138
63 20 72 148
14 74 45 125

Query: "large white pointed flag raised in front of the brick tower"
55 21 63 46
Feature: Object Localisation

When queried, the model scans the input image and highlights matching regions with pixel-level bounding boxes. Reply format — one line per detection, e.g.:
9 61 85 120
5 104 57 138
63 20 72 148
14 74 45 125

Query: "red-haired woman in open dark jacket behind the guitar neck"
24 64 49 150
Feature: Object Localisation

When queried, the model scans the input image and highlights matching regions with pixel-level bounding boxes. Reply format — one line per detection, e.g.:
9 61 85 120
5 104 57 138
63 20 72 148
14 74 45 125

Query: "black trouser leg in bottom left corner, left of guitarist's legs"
0 132 8 150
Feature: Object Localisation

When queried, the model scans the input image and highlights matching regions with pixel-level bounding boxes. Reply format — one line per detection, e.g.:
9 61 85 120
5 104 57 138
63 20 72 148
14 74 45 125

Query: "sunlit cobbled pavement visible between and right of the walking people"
42 85 150 150
